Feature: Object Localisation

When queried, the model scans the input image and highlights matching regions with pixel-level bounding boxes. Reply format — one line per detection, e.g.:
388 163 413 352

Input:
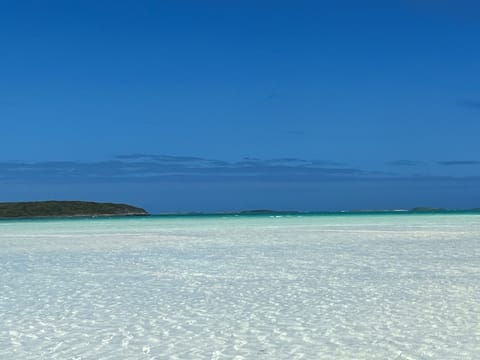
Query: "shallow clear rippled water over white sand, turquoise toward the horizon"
0 215 480 360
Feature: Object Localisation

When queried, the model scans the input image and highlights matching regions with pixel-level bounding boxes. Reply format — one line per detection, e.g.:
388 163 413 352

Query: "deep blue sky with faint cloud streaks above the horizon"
0 0 480 212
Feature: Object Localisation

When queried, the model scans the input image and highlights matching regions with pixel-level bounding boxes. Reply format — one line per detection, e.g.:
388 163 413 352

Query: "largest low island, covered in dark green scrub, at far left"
0 201 149 219
